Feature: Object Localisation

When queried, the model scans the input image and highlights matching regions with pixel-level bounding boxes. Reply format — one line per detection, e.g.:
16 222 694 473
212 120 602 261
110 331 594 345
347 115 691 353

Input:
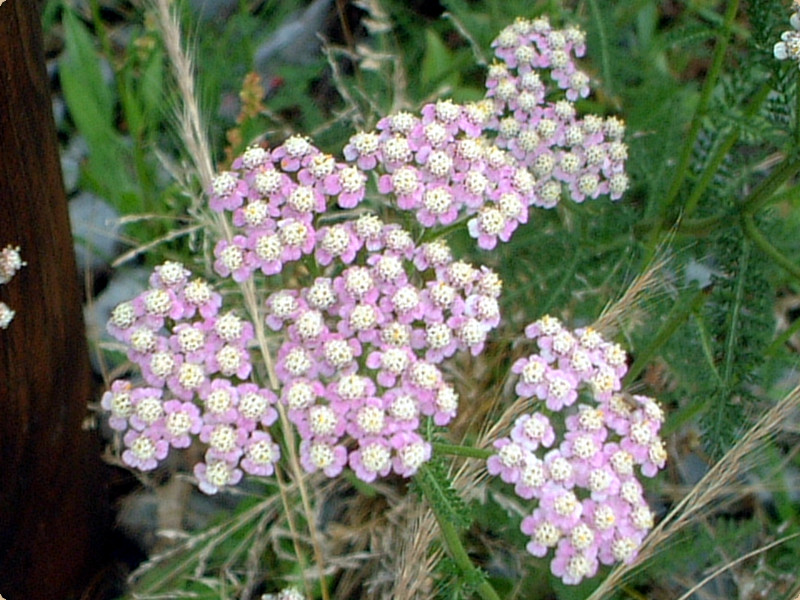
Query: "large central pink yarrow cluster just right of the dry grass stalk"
266 215 501 482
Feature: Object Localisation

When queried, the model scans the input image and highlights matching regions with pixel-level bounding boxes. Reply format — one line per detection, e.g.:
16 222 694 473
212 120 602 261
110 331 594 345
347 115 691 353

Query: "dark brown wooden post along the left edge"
0 0 109 600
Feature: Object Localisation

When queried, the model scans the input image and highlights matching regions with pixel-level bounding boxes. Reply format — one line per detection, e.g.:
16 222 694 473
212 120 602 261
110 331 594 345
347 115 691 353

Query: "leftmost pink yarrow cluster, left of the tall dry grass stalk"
101 262 280 494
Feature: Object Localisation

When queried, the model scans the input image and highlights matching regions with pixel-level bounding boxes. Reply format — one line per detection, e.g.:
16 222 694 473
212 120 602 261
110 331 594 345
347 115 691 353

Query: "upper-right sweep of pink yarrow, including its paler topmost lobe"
344 18 628 249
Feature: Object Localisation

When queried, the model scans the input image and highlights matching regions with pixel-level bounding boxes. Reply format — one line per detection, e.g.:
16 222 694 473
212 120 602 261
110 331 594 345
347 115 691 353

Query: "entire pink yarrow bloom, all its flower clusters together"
101 11 665 594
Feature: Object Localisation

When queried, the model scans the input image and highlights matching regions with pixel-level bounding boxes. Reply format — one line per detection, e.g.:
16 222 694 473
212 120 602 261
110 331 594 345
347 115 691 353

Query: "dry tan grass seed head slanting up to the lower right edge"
588 387 800 600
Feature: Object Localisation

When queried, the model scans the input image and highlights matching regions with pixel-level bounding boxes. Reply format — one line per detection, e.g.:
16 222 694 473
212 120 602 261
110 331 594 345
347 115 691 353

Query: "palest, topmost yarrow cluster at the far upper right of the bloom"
487 17 628 208
